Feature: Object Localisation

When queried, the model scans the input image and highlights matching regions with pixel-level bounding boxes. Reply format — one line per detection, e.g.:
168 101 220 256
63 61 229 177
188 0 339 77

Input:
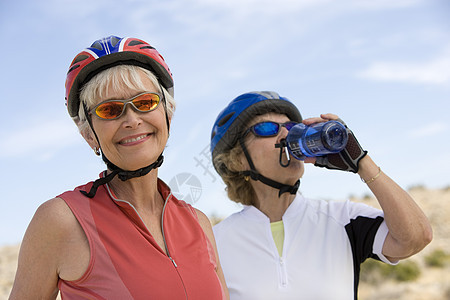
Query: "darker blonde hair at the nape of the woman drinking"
214 143 256 205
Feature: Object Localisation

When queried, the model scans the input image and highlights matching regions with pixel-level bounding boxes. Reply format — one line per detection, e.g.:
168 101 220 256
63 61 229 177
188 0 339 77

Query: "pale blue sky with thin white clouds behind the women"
0 0 450 245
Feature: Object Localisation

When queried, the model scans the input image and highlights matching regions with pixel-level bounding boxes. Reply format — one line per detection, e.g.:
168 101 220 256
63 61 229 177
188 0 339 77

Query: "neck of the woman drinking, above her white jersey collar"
252 181 295 222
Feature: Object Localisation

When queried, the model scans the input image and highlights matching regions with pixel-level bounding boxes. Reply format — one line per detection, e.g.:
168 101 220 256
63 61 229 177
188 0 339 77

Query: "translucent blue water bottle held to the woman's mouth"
286 121 348 160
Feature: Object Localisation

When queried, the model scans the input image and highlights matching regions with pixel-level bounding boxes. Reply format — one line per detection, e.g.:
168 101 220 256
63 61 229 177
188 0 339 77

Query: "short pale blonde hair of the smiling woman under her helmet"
74 65 175 135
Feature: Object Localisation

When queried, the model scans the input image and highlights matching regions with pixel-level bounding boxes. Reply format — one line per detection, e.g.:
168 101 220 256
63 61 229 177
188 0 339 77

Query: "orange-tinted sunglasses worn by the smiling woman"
91 92 161 120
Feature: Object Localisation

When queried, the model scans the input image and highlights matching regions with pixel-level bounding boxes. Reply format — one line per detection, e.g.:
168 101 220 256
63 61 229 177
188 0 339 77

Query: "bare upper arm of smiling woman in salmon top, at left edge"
9 198 89 300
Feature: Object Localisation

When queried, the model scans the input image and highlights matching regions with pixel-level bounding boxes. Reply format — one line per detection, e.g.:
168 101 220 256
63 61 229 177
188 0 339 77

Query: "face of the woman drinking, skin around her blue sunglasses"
241 113 304 185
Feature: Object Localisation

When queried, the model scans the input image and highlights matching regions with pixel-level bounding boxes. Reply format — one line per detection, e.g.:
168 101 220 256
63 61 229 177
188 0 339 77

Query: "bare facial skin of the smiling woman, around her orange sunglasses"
87 72 168 170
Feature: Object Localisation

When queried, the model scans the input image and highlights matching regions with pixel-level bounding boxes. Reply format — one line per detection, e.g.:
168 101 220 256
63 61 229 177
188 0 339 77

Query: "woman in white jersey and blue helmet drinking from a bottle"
211 92 432 300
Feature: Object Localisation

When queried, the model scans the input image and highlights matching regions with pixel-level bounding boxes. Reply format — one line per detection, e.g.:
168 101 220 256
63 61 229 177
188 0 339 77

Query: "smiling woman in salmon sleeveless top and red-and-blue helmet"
10 36 228 299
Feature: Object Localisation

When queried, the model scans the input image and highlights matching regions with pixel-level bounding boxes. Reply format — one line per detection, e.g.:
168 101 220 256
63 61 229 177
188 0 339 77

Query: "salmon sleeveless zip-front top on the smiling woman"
58 179 225 300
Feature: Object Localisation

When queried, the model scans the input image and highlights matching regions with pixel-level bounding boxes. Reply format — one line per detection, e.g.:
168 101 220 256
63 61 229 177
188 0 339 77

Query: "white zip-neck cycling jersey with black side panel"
214 194 390 300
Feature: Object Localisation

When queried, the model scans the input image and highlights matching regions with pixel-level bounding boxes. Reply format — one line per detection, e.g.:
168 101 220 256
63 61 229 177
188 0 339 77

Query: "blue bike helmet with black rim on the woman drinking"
211 91 302 174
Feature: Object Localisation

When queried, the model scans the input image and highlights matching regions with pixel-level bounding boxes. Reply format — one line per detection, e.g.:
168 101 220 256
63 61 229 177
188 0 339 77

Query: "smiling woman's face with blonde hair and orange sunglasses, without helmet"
80 65 174 172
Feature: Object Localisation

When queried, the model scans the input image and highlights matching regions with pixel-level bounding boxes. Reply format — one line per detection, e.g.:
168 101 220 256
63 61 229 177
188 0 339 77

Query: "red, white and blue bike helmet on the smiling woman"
66 36 173 118
